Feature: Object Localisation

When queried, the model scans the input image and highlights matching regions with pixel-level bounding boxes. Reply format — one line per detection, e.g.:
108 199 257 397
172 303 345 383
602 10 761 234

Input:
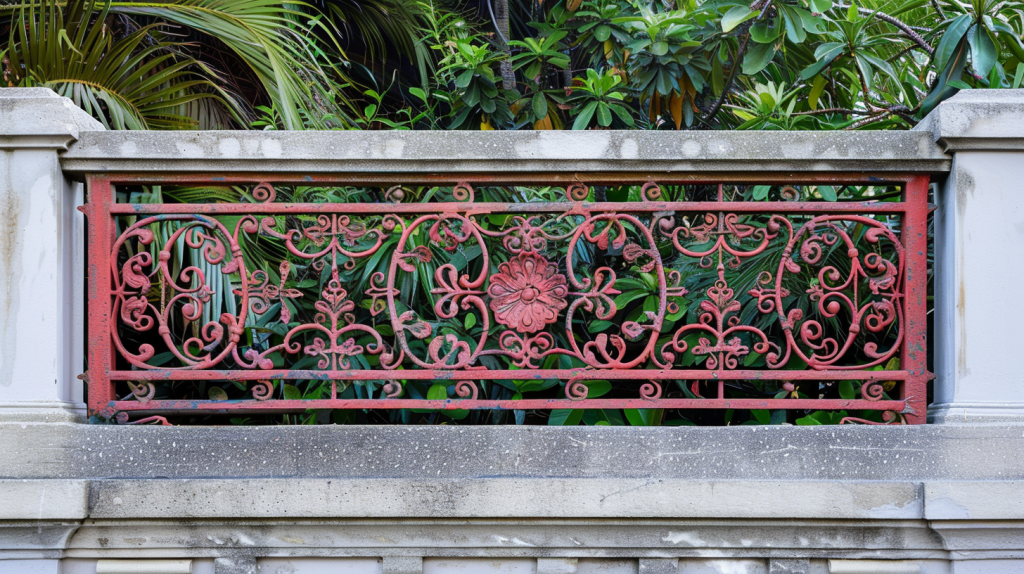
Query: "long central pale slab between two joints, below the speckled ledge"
81 478 924 520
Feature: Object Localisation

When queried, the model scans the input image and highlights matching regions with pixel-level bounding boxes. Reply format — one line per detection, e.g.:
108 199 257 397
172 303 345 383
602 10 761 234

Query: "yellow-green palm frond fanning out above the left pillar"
4 0 241 130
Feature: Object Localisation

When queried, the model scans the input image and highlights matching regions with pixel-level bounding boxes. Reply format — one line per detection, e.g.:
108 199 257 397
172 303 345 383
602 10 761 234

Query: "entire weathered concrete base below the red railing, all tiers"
0 424 1024 574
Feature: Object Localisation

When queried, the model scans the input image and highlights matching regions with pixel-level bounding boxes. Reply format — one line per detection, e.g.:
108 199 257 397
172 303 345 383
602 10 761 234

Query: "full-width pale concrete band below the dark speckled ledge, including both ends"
0 478 1024 521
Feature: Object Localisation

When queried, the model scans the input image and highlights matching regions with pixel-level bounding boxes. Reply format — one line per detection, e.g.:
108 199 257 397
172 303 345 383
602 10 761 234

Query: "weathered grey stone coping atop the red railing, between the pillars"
61 131 950 177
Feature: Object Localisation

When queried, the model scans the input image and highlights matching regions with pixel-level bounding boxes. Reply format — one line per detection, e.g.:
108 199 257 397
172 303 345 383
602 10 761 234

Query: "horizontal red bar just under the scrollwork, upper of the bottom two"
106 368 914 381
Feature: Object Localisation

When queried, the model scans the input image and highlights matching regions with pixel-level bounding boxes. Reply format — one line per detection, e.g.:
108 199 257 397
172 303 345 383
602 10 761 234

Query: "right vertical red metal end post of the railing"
900 175 929 425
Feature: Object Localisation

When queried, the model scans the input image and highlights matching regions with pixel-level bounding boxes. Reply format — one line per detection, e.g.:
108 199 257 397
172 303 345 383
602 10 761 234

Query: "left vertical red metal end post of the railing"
82 176 117 415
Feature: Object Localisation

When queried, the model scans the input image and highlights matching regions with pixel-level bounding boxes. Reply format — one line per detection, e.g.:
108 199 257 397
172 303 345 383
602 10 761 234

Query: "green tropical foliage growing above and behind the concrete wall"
0 0 991 424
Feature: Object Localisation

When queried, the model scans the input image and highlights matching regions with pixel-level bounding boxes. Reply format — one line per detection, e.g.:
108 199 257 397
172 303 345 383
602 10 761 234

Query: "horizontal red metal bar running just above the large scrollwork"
110 202 907 215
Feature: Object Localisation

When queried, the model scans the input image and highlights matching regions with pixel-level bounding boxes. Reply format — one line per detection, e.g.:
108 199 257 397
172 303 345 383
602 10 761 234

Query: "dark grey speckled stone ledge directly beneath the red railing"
0 423 1024 482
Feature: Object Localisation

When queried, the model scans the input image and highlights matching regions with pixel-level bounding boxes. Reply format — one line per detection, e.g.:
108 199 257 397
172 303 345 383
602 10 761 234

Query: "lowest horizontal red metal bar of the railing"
110 399 906 413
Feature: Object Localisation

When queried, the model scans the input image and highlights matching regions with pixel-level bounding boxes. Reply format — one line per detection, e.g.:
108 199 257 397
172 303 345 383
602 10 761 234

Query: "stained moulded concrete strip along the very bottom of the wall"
0 517 1024 574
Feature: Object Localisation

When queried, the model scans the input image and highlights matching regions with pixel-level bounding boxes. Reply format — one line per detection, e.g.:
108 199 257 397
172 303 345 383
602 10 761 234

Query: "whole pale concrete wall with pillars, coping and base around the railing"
0 89 1024 574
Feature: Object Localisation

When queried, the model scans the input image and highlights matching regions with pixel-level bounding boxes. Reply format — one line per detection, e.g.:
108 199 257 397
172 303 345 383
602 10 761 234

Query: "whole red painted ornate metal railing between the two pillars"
83 174 931 424
